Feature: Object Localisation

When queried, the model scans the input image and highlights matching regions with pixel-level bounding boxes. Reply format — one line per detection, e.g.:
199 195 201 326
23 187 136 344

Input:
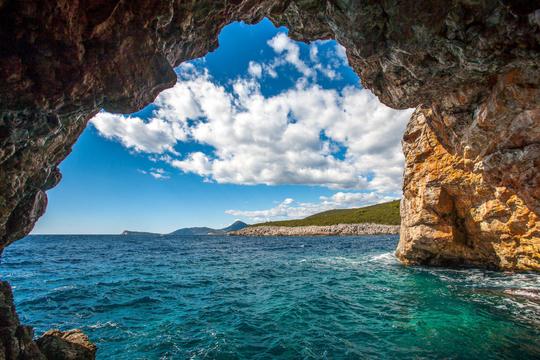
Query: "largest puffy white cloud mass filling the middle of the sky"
91 33 412 194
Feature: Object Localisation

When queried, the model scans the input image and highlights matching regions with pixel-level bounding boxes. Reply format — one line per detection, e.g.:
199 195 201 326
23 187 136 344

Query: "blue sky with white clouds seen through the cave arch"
33 19 412 234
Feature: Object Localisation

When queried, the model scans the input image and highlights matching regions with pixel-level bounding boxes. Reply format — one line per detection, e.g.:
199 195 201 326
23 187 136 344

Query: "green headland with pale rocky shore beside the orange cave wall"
229 200 400 236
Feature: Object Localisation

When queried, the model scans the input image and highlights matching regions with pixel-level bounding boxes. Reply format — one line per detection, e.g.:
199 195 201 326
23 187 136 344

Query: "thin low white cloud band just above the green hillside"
225 192 395 222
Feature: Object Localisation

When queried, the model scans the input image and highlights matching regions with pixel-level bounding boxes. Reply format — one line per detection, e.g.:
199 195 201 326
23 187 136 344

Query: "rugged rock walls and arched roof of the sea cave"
0 0 540 359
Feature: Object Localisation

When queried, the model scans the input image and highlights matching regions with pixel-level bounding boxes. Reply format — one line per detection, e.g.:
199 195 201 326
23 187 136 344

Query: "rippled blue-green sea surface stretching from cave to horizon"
0 235 540 360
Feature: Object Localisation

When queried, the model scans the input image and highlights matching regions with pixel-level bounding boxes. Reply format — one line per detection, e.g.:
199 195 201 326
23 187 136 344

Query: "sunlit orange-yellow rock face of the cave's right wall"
396 107 540 270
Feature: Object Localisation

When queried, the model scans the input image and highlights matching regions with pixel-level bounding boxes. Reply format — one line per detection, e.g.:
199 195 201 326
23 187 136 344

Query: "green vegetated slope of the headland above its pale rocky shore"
252 200 400 226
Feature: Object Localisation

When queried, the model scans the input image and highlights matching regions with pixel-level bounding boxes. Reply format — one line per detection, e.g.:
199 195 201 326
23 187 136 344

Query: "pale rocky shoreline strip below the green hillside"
229 223 399 236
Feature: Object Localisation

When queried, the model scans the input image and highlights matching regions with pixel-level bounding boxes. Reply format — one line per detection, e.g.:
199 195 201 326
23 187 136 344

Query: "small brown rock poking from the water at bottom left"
37 329 96 360
